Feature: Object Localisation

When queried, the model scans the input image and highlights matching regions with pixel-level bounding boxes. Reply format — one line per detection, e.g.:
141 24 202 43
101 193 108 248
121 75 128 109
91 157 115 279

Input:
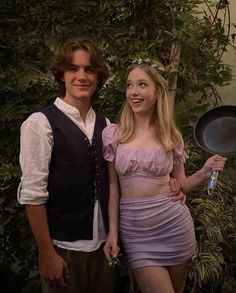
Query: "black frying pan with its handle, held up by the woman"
194 105 236 192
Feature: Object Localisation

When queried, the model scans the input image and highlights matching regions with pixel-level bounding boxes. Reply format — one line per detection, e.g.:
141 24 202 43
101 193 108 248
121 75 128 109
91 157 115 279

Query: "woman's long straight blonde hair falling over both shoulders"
119 63 181 152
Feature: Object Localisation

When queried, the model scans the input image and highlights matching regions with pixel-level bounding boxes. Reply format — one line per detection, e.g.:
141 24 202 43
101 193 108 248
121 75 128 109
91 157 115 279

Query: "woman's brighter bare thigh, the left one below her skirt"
134 267 175 293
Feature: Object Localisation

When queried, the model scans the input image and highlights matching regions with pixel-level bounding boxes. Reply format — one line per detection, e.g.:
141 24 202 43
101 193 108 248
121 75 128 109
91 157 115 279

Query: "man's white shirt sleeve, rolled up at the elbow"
17 112 53 205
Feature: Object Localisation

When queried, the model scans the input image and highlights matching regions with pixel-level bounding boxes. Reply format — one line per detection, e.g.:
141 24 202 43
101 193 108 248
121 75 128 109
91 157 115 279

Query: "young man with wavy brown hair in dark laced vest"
18 39 113 293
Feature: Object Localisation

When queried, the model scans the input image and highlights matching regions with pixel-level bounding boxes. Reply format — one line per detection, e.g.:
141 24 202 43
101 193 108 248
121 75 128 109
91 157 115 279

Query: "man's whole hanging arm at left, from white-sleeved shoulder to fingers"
18 113 67 286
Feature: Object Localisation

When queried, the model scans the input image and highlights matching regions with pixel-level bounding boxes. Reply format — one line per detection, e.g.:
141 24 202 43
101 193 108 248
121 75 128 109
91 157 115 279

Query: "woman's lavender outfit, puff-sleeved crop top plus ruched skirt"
103 124 195 269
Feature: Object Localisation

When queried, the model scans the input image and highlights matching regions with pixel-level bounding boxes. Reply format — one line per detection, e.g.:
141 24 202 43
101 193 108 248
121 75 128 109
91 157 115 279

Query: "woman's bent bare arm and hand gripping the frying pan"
171 155 226 192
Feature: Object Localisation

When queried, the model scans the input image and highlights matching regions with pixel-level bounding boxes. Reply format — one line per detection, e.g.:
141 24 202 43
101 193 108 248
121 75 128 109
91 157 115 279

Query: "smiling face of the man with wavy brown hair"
63 49 98 105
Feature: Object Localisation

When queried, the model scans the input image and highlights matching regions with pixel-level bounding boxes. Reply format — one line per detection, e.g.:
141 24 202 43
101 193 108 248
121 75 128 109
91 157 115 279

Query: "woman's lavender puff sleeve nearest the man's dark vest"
102 123 117 162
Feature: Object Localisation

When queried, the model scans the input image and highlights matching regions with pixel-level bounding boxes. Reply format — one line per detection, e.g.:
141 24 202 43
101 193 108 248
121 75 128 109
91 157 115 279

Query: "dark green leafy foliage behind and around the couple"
0 0 236 292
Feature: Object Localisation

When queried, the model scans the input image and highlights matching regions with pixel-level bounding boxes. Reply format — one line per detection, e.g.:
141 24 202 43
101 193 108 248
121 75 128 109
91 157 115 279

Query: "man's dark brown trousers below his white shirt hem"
41 247 115 293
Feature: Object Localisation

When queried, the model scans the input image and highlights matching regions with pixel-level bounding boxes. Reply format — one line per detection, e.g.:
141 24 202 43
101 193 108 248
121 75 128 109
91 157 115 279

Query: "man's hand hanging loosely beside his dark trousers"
41 254 69 288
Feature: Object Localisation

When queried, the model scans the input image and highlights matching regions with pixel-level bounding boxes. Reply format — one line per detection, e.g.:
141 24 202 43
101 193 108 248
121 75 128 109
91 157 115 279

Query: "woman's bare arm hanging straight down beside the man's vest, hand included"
104 162 119 259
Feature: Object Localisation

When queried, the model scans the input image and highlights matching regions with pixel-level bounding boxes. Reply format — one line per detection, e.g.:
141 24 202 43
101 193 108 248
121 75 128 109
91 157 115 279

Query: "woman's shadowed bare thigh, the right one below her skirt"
168 262 189 293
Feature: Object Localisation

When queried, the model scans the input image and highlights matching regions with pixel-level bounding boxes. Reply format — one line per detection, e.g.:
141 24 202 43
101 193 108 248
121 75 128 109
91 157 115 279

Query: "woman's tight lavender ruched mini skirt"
120 194 196 269
